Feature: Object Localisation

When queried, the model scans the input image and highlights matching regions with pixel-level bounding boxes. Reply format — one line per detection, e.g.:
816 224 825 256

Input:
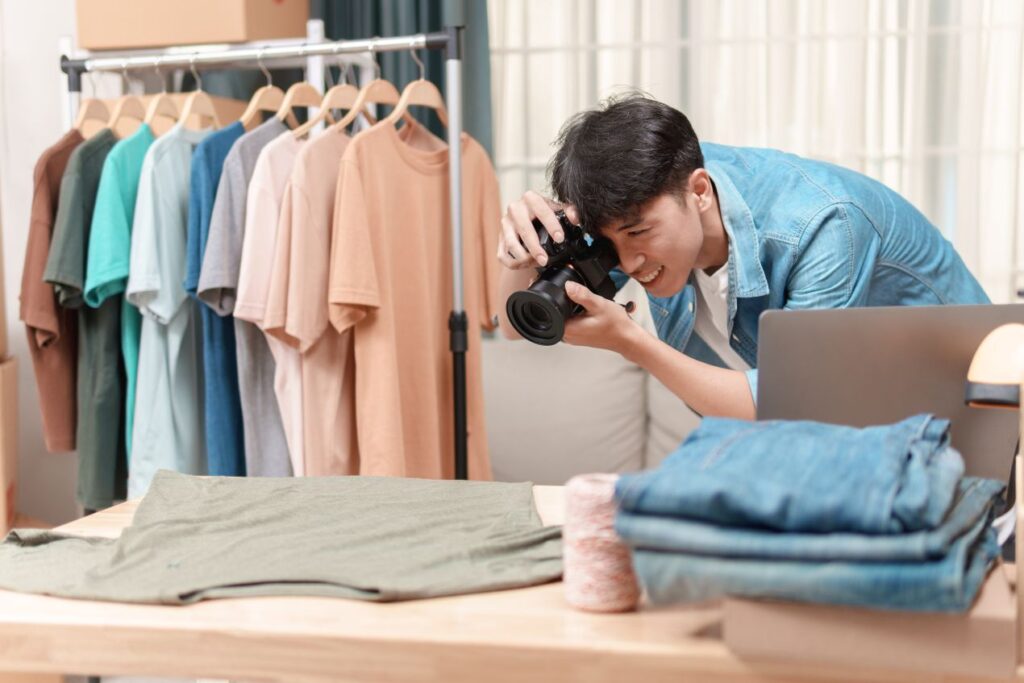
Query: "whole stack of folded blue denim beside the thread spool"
615 415 1002 611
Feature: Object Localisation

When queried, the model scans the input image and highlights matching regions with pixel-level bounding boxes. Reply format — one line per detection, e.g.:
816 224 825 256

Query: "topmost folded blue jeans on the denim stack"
615 415 964 533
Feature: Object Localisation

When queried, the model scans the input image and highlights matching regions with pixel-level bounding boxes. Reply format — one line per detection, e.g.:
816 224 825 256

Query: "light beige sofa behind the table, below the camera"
482 282 698 484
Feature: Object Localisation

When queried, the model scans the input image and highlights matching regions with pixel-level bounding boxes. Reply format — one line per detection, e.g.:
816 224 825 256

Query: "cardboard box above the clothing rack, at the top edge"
76 0 309 50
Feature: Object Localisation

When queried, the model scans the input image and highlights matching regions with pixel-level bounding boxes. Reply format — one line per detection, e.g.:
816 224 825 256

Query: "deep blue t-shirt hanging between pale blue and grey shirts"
184 121 246 476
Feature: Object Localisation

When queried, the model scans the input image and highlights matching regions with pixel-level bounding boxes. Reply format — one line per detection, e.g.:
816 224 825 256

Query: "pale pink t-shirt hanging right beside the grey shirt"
234 131 305 476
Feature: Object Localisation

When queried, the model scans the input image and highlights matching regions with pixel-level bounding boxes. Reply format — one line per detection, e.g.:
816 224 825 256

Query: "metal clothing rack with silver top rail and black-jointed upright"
60 20 469 479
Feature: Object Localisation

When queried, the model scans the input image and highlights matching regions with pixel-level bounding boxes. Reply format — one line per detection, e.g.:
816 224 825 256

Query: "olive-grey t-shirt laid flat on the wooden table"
0 471 562 604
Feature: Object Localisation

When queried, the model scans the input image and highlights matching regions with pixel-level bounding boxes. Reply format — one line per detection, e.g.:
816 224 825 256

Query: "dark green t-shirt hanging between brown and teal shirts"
43 129 127 510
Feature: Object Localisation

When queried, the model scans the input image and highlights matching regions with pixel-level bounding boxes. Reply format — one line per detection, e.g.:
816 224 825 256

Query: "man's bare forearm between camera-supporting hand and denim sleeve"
623 328 755 420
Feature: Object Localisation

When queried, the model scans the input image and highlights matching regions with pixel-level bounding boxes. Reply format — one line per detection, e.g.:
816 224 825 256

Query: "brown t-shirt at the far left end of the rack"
19 128 84 453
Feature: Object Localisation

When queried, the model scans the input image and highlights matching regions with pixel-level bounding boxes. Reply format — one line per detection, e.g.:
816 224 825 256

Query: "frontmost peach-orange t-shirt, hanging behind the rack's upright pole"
329 124 501 479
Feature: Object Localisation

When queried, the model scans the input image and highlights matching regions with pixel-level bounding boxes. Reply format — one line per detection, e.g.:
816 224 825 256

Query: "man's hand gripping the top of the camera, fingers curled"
498 189 580 270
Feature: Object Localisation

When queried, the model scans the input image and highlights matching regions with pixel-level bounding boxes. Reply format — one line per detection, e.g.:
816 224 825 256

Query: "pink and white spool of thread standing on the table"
562 474 640 612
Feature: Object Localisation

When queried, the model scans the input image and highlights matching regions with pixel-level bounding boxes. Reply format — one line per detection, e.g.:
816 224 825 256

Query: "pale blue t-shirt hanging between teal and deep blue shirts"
126 124 210 498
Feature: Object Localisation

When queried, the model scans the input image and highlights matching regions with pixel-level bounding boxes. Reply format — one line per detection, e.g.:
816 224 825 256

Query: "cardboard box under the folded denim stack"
724 565 1017 680
